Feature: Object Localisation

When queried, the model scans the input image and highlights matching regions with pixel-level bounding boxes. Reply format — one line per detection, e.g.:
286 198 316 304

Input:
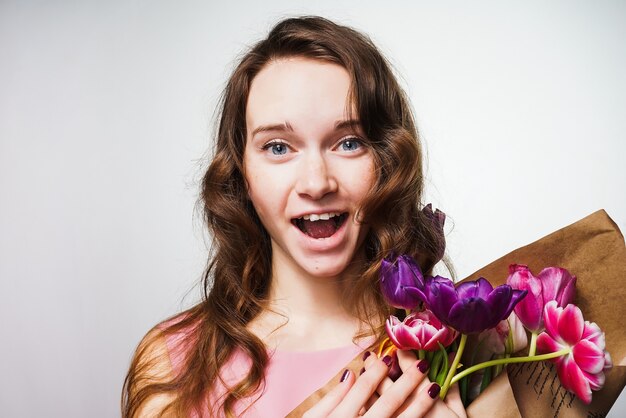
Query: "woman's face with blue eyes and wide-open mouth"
244 58 375 277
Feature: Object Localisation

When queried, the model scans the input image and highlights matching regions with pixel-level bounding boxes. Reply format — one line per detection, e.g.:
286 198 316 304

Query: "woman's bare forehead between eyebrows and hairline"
246 58 354 132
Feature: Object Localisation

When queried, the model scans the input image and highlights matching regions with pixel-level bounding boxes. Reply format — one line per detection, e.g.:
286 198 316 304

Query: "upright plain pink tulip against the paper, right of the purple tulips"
507 264 576 333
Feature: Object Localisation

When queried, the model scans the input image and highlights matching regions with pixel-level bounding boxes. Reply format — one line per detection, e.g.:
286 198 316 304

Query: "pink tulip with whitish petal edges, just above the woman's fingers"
385 310 458 351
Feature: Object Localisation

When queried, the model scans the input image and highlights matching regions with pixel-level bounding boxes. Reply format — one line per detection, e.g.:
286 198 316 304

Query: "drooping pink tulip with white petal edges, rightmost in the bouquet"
537 301 612 404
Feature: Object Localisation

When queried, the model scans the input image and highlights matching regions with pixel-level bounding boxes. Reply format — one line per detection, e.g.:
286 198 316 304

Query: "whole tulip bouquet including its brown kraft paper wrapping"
288 211 626 418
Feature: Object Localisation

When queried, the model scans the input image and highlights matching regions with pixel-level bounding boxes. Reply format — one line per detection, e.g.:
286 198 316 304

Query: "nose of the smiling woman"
295 153 337 200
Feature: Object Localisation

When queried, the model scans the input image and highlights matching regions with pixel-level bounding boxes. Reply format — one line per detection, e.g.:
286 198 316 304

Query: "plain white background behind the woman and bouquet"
0 0 626 417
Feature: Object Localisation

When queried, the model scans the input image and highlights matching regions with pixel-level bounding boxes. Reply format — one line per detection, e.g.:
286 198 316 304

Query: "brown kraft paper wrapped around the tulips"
287 210 626 418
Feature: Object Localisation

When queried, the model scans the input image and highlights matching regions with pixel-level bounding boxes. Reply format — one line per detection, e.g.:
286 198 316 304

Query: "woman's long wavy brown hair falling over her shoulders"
122 16 445 417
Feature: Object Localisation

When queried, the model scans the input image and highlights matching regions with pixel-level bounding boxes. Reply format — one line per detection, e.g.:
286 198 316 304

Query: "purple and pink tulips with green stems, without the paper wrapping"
379 233 612 405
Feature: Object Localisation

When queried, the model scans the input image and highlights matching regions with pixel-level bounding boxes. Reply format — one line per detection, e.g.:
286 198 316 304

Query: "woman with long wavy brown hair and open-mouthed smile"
122 17 464 417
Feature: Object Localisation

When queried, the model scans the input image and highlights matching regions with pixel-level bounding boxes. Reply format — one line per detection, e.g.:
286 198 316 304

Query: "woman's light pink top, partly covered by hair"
160 316 373 418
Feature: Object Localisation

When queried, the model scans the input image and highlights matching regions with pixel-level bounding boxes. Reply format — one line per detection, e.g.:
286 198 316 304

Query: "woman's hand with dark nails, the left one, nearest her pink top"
303 356 438 418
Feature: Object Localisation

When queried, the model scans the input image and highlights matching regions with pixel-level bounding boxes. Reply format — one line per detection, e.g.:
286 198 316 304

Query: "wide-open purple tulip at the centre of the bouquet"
425 276 527 334
